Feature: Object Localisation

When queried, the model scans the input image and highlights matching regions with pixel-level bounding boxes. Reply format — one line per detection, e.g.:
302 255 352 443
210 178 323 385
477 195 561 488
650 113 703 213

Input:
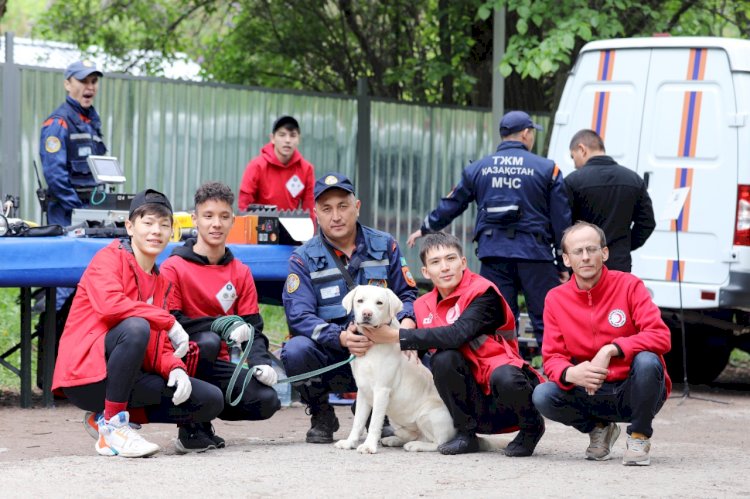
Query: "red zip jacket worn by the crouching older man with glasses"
542 267 672 395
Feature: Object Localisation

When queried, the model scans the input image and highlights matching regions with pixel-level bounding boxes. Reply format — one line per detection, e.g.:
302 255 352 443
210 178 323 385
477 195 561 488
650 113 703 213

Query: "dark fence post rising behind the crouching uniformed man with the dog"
355 78 376 225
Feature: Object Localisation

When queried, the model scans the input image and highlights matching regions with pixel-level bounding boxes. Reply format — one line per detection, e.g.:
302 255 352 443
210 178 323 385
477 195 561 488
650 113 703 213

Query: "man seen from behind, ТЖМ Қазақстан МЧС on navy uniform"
407 111 571 347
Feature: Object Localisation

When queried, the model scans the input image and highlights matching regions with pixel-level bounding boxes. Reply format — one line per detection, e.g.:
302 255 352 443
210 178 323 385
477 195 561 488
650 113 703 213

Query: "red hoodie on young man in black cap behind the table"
237 142 315 219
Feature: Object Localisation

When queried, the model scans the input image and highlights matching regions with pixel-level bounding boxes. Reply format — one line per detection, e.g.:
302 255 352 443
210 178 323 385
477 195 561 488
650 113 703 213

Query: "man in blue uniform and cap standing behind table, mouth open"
39 61 107 310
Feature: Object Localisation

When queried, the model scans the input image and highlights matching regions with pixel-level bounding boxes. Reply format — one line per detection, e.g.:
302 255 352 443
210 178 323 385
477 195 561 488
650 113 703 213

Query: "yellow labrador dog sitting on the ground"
335 286 456 454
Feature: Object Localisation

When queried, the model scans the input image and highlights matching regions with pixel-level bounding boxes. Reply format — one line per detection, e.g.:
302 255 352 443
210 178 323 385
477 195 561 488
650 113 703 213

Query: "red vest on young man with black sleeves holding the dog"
414 269 542 394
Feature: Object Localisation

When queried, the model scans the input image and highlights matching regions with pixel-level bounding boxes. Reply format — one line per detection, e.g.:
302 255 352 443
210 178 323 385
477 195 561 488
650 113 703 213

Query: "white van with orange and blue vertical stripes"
549 37 750 383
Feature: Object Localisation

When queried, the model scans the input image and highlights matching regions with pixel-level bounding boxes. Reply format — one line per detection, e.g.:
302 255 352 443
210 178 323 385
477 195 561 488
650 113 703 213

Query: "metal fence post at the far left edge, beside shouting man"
0 33 25 201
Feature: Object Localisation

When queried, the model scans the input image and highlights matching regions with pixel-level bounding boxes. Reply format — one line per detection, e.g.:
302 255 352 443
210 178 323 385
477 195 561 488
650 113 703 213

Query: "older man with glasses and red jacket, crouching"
533 222 672 466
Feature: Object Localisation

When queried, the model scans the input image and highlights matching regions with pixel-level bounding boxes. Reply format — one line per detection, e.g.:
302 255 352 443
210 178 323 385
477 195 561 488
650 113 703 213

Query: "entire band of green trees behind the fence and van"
32 0 750 111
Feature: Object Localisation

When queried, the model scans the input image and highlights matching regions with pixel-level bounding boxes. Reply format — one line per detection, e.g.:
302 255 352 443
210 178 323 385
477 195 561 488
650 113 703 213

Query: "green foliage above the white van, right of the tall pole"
477 0 750 80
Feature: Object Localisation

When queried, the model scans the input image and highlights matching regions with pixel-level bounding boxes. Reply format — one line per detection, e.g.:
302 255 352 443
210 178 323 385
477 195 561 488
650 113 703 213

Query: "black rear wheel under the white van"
664 321 732 384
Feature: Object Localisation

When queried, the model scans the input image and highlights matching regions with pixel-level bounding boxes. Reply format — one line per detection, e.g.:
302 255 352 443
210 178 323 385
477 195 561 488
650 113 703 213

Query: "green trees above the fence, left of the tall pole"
37 0 492 105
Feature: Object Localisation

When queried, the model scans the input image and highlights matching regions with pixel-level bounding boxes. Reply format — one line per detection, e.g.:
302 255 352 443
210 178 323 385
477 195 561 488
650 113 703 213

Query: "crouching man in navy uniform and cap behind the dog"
281 173 417 443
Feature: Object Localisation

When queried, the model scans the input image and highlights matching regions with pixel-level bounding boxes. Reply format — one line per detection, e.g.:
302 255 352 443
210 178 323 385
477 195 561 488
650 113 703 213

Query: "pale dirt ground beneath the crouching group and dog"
0 373 750 498
